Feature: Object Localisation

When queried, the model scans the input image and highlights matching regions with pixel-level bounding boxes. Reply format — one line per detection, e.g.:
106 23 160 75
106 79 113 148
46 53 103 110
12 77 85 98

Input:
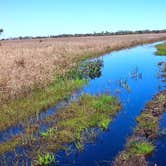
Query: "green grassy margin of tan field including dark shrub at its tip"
0 60 103 130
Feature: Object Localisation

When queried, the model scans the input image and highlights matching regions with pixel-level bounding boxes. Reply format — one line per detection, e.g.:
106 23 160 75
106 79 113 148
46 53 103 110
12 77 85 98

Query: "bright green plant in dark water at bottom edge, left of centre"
37 153 55 166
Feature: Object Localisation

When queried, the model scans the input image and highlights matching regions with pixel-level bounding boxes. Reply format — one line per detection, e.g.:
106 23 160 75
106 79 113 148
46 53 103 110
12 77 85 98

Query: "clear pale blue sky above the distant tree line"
0 0 166 38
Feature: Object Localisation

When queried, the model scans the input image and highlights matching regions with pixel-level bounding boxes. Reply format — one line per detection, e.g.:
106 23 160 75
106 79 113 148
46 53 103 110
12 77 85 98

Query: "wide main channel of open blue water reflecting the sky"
57 45 165 166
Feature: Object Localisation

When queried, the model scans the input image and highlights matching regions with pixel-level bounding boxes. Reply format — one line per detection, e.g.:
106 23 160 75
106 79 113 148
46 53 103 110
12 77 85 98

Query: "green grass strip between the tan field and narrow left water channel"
0 78 87 130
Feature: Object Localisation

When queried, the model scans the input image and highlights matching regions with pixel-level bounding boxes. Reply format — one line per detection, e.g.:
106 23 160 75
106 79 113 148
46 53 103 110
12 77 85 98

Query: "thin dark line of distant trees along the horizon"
0 29 166 41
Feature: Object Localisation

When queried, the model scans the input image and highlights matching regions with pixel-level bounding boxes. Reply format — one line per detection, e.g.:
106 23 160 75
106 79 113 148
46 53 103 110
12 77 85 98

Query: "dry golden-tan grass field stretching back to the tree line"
0 33 166 102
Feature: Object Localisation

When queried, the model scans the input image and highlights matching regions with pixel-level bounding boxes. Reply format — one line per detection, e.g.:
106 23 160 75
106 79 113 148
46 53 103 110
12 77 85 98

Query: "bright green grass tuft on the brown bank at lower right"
129 141 155 155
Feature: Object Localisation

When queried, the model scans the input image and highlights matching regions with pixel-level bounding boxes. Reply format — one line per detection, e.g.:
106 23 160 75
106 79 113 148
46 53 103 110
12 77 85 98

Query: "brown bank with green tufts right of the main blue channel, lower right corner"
114 91 166 166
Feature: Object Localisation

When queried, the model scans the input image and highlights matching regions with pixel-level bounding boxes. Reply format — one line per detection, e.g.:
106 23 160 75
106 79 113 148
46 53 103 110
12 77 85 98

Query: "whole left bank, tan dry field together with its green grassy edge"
0 34 166 130
